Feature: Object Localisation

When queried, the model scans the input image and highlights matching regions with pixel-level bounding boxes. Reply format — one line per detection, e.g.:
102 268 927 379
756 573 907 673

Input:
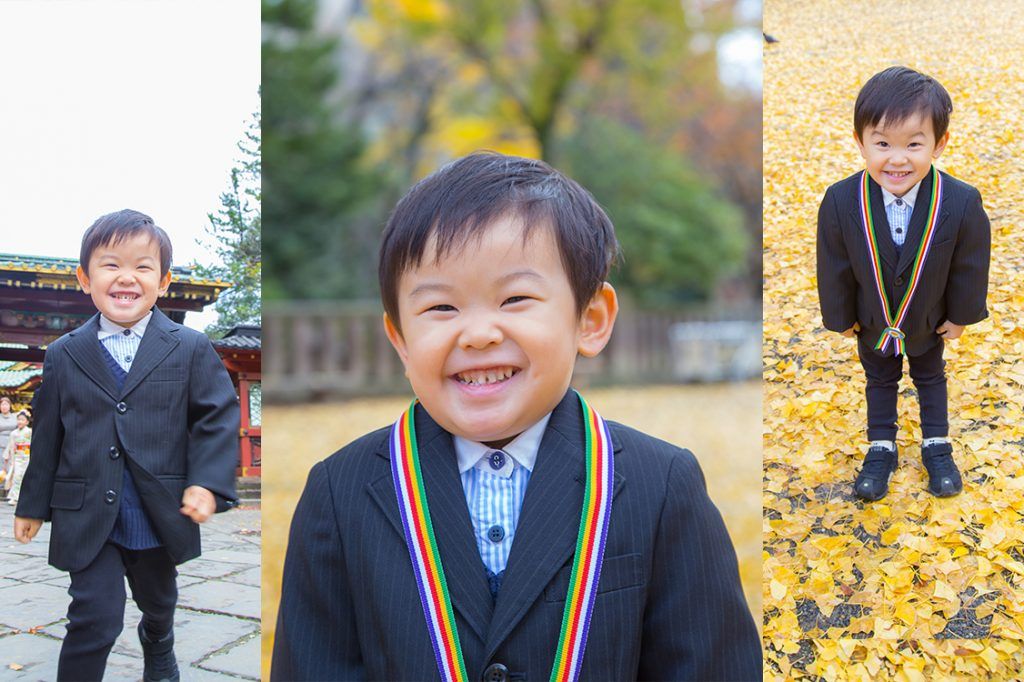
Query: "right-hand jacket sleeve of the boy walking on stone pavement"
187 337 241 512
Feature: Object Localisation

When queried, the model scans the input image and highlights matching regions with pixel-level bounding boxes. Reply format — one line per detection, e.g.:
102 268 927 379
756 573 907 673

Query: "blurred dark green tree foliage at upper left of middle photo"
262 0 380 299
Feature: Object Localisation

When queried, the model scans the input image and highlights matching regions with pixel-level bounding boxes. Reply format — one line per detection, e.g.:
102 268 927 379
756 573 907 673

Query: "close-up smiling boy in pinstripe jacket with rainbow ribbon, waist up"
271 154 761 681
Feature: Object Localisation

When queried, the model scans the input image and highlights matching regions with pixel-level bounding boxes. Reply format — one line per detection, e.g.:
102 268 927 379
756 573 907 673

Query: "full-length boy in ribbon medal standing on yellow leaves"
817 67 990 501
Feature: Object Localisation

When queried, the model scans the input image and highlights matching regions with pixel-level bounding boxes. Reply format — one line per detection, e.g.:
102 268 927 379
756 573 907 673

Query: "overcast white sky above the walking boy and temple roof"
0 0 260 328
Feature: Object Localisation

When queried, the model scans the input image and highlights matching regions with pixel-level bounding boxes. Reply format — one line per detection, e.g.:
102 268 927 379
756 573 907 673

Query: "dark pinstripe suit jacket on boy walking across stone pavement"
16 308 239 571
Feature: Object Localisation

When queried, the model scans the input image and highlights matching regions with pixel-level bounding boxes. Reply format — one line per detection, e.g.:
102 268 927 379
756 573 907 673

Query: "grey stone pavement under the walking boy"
0 501 261 682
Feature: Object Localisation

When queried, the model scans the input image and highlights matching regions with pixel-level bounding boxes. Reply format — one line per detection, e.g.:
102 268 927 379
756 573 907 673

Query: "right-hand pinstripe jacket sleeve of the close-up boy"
638 451 761 682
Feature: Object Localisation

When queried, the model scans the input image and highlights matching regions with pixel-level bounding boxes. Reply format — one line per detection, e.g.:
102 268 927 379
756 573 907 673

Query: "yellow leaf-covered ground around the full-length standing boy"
763 0 1024 680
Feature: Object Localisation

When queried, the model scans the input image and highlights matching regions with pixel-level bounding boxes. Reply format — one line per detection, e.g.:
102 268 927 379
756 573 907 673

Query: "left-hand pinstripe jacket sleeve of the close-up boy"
270 462 366 682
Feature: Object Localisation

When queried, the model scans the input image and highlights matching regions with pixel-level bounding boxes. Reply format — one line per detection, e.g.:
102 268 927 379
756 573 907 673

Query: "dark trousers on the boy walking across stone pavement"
57 543 178 682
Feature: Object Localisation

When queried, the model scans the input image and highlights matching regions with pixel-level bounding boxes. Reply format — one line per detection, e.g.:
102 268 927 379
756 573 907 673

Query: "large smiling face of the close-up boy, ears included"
384 218 617 446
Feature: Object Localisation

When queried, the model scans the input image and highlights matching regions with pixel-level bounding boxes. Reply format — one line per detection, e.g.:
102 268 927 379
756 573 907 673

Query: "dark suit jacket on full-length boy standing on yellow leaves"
817 171 991 355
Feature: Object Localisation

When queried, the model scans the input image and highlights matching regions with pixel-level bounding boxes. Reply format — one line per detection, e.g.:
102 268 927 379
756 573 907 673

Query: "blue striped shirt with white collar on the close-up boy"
454 413 551 574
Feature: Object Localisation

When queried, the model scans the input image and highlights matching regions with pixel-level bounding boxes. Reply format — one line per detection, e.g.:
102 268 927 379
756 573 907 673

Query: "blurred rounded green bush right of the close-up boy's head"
559 119 750 306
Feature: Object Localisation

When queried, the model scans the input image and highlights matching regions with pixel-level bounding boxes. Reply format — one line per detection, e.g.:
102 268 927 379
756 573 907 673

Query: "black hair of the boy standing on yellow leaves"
853 67 953 141
